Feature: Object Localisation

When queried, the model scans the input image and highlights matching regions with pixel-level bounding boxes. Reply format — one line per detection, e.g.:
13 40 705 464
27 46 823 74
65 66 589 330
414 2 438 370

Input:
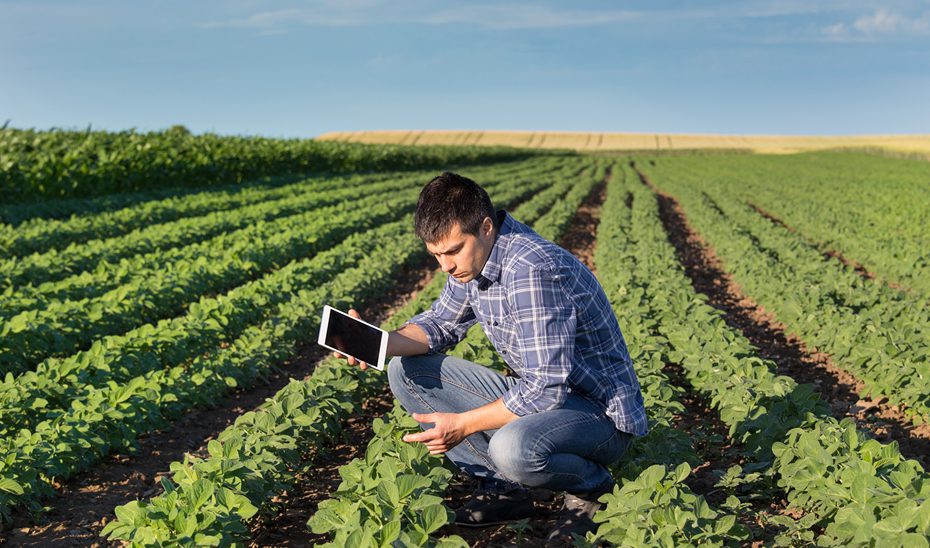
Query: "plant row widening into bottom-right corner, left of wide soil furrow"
631 163 930 546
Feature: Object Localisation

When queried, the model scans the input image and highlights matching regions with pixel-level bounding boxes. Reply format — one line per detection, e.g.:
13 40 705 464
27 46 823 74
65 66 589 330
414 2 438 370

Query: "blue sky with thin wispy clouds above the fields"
0 0 930 137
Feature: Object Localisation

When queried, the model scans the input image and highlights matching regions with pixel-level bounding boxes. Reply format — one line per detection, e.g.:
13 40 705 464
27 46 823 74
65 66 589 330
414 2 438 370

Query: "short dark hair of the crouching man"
413 171 497 243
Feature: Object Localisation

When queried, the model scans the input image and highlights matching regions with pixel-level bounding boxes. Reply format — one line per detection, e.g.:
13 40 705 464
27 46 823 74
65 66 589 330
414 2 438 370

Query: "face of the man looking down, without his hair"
426 217 495 283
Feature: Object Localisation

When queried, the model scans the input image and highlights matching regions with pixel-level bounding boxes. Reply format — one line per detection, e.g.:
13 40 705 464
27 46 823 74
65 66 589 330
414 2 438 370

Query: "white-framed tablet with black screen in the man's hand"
317 305 388 371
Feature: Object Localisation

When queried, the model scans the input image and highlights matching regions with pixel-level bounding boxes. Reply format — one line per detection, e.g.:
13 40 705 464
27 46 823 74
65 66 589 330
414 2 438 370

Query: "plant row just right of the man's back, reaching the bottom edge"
576 165 750 546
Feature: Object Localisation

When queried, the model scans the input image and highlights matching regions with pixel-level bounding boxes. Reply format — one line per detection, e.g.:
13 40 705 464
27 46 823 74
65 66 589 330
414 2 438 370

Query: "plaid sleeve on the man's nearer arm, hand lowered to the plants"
503 266 577 416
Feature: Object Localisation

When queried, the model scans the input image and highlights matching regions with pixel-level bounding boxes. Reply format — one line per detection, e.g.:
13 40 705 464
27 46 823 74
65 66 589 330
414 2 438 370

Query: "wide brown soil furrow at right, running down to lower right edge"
637 164 930 468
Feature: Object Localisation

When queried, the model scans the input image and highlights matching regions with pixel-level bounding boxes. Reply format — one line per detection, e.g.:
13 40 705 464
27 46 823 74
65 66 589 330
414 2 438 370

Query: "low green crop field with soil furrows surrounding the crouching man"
0 133 930 547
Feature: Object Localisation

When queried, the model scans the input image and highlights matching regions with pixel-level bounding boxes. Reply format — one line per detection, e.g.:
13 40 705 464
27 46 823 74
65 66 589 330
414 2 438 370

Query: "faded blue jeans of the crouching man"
388 354 632 493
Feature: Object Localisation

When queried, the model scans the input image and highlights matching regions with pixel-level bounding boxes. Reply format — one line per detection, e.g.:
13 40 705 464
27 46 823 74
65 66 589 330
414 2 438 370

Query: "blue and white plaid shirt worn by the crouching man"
408 211 648 435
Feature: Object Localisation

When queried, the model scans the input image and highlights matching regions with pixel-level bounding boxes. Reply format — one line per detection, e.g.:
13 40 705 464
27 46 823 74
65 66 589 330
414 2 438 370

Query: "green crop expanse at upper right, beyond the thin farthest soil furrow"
644 152 930 300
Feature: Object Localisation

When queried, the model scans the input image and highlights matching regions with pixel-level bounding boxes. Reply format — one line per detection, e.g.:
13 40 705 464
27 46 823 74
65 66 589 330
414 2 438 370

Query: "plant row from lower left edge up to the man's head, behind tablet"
0 219 411 513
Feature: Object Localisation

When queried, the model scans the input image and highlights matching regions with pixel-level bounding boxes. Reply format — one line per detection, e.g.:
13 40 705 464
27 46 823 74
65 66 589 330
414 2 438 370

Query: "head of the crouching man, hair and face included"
414 171 497 283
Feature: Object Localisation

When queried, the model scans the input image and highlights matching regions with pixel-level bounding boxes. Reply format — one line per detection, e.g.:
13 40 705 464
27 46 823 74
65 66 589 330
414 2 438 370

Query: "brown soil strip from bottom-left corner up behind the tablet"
0 256 436 546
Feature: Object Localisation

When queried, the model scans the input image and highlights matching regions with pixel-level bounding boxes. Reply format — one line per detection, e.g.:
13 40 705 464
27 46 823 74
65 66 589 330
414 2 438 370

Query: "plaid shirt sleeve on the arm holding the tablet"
406 277 478 354
